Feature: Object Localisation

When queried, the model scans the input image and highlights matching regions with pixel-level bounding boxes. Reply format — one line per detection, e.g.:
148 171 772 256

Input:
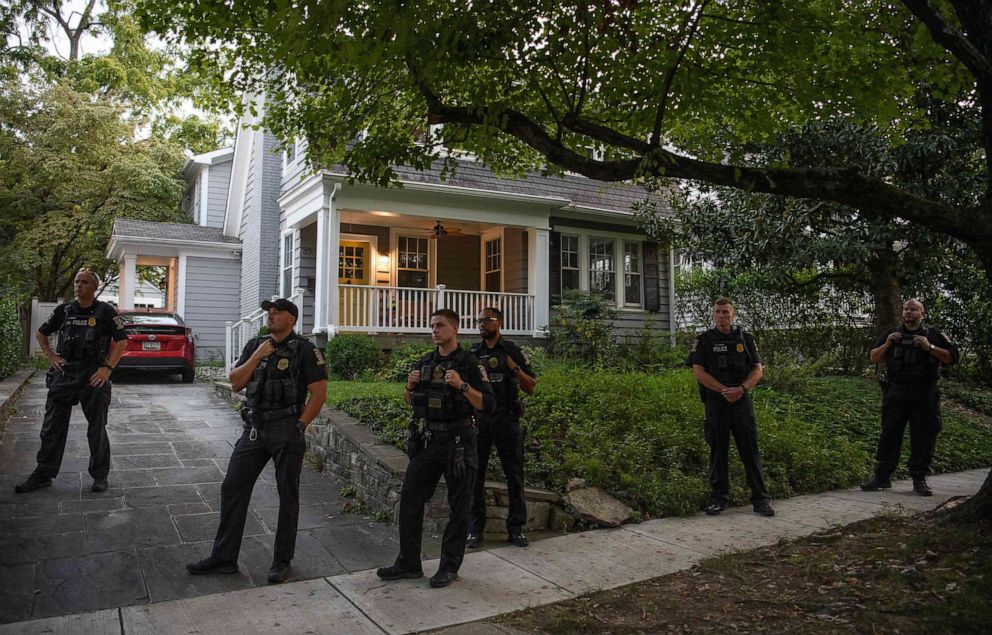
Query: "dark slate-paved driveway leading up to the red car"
0 374 426 623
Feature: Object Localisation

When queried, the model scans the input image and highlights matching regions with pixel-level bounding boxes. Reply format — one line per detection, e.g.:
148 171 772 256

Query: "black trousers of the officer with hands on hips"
35 365 110 479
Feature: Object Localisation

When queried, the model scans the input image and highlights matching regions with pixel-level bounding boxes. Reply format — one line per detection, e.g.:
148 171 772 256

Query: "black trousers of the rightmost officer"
875 383 940 479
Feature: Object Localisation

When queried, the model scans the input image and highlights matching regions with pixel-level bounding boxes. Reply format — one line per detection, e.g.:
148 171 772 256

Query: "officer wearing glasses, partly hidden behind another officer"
466 307 536 549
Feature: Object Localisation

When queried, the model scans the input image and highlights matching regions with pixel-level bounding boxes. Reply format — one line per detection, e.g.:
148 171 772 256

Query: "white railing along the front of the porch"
337 284 535 335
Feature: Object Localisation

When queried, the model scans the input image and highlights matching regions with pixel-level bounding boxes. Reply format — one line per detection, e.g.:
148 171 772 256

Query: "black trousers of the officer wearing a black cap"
213 417 307 562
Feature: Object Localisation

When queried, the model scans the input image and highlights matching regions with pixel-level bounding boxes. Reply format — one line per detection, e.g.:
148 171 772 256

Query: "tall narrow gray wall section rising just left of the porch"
239 132 282 315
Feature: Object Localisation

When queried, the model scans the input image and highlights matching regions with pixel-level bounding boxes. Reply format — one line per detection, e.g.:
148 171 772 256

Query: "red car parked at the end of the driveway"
118 311 196 383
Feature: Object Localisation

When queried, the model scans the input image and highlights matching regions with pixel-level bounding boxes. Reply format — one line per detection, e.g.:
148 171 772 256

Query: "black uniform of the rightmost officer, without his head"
874 324 958 481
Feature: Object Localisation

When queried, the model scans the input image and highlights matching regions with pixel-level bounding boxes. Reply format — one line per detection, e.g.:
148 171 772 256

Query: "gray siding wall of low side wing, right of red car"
183 257 240 359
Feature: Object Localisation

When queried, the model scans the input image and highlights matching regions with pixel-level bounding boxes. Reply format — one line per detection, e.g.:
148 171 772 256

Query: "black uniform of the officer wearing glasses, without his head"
469 337 535 536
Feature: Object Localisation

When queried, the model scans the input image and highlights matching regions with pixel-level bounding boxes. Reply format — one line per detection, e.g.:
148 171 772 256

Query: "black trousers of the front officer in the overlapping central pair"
396 426 478 573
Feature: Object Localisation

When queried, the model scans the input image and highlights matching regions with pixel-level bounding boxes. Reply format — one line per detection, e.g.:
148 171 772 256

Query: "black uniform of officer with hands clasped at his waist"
689 327 770 505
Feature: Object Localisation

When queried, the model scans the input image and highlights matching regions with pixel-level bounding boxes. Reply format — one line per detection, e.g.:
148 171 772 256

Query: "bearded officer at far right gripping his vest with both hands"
861 298 958 496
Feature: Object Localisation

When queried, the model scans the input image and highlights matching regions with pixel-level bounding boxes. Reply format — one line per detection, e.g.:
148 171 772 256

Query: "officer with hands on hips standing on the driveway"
14 268 127 494
